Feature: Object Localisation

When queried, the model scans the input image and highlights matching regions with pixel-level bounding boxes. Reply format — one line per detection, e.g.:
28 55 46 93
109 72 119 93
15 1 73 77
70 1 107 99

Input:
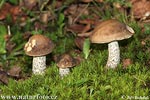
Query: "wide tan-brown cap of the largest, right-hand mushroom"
90 19 134 43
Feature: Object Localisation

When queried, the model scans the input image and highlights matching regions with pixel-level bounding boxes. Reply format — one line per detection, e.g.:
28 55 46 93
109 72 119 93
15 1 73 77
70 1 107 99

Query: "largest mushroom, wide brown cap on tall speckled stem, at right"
78 19 134 68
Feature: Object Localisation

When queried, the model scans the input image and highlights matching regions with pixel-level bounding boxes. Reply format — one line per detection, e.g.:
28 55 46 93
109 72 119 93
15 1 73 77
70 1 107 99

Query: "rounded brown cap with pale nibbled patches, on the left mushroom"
24 34 54 56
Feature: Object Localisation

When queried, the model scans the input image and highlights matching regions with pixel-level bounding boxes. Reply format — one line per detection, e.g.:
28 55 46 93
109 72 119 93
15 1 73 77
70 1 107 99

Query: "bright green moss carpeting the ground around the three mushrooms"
0 0 150 100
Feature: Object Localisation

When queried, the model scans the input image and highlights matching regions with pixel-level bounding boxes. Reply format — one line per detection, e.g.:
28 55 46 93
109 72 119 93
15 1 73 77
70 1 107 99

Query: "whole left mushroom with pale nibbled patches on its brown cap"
24 34 54 74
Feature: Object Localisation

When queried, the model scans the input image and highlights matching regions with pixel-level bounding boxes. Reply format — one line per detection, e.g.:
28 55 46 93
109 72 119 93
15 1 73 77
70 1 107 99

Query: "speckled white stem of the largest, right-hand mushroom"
106 41 120 68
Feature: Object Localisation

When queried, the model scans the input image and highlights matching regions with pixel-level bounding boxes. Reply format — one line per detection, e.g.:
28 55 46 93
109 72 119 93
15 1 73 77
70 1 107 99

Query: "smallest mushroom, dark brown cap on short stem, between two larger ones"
56 54 79 78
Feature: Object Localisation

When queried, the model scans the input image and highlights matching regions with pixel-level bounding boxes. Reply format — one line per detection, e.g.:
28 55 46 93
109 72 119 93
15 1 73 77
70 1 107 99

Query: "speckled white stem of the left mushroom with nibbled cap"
32 56 46 74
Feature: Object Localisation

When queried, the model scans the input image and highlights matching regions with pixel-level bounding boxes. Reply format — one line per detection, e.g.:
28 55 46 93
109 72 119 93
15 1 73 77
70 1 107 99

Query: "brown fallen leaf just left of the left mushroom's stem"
7 66 21 77
